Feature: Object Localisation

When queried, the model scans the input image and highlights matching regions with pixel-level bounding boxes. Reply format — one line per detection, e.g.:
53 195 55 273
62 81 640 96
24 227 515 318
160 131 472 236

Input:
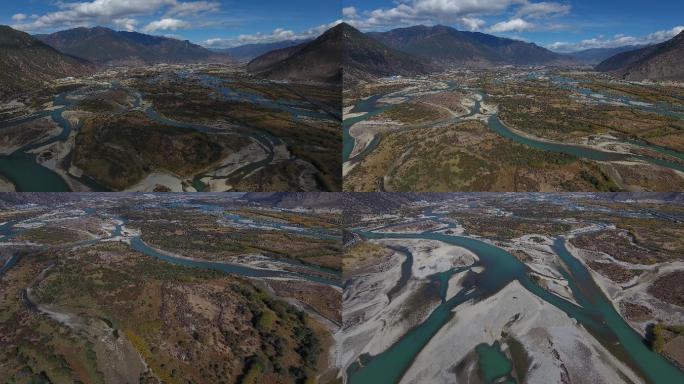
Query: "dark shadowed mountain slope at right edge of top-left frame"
247 24 343 83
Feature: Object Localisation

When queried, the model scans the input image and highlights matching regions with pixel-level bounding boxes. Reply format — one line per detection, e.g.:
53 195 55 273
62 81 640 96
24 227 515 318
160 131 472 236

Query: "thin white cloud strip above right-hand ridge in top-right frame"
547 25 684 52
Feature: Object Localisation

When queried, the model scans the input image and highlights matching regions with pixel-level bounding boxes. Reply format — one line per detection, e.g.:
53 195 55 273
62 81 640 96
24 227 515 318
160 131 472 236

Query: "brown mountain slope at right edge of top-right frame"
595 31 684 81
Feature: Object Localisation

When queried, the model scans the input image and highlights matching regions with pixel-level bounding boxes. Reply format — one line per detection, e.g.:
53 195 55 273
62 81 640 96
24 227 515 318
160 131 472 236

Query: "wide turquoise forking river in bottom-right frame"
347 216 684 384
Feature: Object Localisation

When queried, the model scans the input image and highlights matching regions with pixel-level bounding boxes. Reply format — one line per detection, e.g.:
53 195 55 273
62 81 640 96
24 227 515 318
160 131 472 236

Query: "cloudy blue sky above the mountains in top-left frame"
0 0 342 48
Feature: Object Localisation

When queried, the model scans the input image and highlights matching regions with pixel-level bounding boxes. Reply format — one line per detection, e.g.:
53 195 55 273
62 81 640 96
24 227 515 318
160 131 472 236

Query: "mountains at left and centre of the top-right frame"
343 24 578 83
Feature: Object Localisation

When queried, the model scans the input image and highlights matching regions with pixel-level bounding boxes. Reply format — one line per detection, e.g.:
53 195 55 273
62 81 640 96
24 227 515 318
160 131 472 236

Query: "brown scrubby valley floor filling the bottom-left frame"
0 194 342 383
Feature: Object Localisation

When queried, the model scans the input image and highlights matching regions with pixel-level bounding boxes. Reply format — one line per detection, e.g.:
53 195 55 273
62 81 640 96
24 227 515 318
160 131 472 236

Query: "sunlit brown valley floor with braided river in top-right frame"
343 68 684 192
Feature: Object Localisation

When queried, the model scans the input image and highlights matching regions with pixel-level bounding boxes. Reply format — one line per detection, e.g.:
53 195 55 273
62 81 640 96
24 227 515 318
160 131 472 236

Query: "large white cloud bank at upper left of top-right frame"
342 0 571 31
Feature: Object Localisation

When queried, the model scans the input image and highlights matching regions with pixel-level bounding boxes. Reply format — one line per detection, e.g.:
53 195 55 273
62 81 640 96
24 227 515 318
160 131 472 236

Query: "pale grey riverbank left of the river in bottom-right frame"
338 239 476 376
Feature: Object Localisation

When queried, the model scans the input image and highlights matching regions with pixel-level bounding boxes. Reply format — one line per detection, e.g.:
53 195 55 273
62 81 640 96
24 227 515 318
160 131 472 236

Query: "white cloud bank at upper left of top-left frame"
12 0 220 32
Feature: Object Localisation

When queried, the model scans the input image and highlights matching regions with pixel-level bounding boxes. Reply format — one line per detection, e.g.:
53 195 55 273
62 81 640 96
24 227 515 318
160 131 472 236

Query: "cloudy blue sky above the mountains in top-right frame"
342 0 684 52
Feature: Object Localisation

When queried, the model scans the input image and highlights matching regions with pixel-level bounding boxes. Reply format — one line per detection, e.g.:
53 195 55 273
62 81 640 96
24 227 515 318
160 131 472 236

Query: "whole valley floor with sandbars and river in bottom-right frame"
344 194 684 383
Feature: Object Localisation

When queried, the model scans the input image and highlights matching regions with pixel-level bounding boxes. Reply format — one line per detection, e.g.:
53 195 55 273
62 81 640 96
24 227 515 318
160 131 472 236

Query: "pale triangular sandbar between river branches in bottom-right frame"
401 281 642 384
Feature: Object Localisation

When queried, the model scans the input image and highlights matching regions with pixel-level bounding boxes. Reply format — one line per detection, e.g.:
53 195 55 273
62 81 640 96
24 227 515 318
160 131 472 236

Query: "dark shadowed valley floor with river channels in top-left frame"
0 64 341 192
